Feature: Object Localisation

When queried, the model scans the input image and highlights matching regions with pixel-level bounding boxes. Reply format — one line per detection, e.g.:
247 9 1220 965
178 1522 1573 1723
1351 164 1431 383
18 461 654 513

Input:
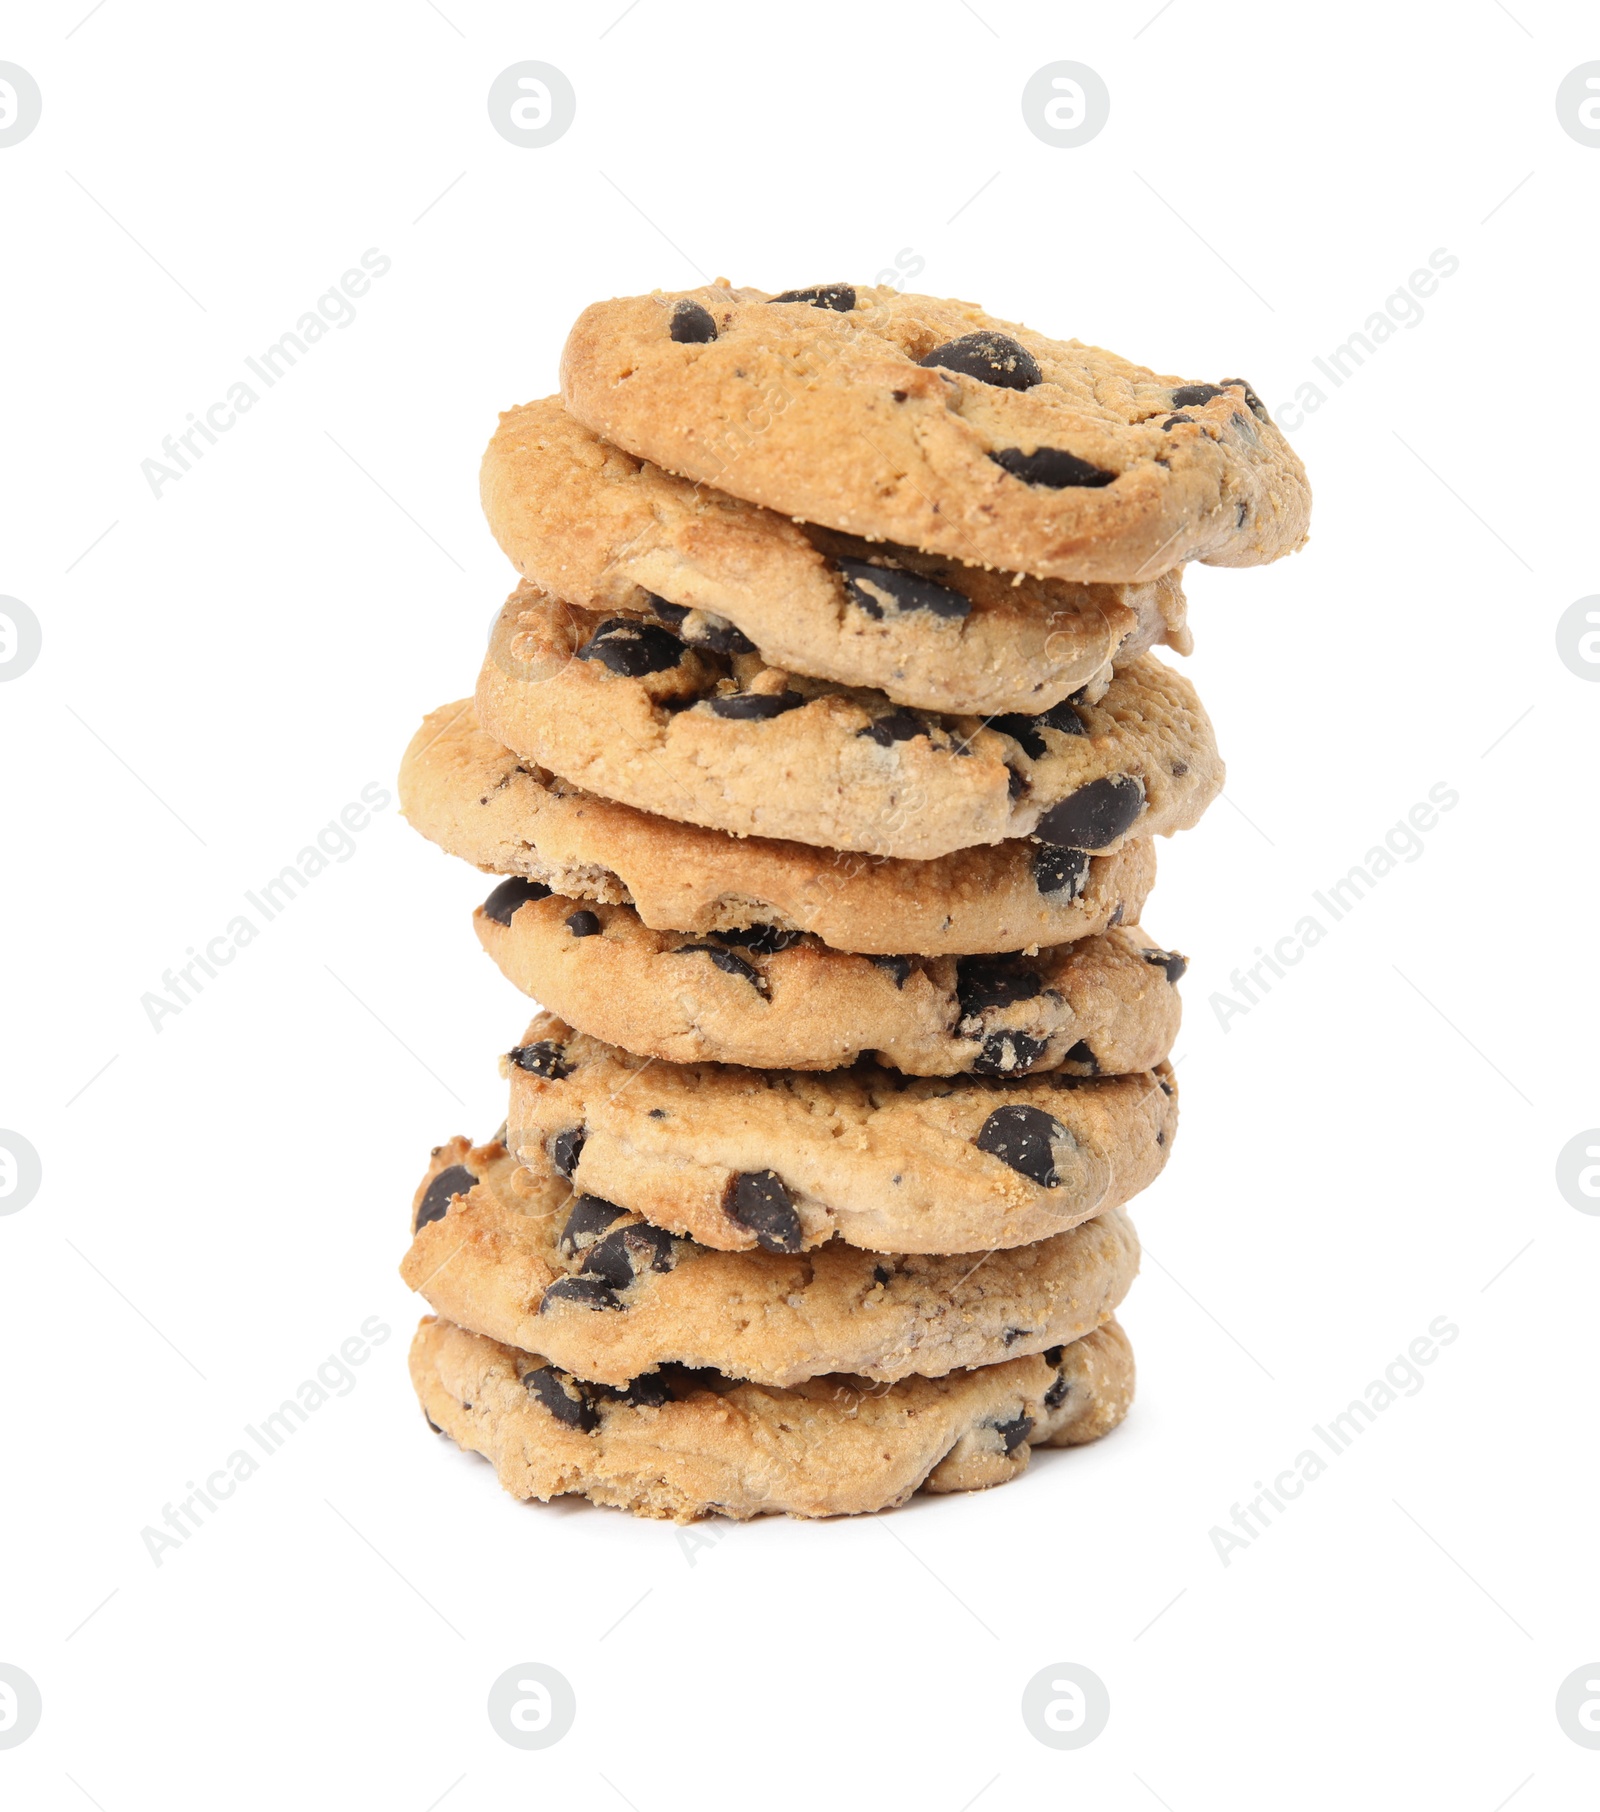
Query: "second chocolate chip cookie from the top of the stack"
480 397 1190 716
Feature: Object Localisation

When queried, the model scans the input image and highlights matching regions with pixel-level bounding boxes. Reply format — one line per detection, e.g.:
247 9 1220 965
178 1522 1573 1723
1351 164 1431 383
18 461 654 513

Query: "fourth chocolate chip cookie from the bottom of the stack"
457 879 1187 1072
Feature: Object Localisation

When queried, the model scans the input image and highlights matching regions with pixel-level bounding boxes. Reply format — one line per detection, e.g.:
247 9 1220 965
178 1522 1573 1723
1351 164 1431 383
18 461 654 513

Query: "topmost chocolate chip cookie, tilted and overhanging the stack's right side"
562 284 1310 582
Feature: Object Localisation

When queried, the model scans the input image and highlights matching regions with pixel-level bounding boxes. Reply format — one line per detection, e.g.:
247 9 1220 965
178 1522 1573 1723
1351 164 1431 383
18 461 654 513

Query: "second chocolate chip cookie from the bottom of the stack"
400 1138 1138 1386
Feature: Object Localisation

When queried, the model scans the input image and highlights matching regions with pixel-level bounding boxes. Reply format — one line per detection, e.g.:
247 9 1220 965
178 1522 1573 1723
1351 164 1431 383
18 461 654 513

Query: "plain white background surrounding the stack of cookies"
0 0 1600 1812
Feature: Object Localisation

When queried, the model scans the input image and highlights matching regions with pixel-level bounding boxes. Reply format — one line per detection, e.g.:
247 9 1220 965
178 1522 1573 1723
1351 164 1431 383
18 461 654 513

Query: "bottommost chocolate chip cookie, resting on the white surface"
411 1316 1134 1522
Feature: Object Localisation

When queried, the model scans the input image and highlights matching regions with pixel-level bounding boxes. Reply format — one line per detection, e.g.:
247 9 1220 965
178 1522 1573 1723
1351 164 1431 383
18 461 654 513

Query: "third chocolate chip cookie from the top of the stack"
477 580 1223 861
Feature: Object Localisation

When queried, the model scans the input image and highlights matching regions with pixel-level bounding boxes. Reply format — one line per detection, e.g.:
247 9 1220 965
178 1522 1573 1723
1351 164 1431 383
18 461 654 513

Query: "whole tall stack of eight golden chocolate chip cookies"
400 283 1310 1520
